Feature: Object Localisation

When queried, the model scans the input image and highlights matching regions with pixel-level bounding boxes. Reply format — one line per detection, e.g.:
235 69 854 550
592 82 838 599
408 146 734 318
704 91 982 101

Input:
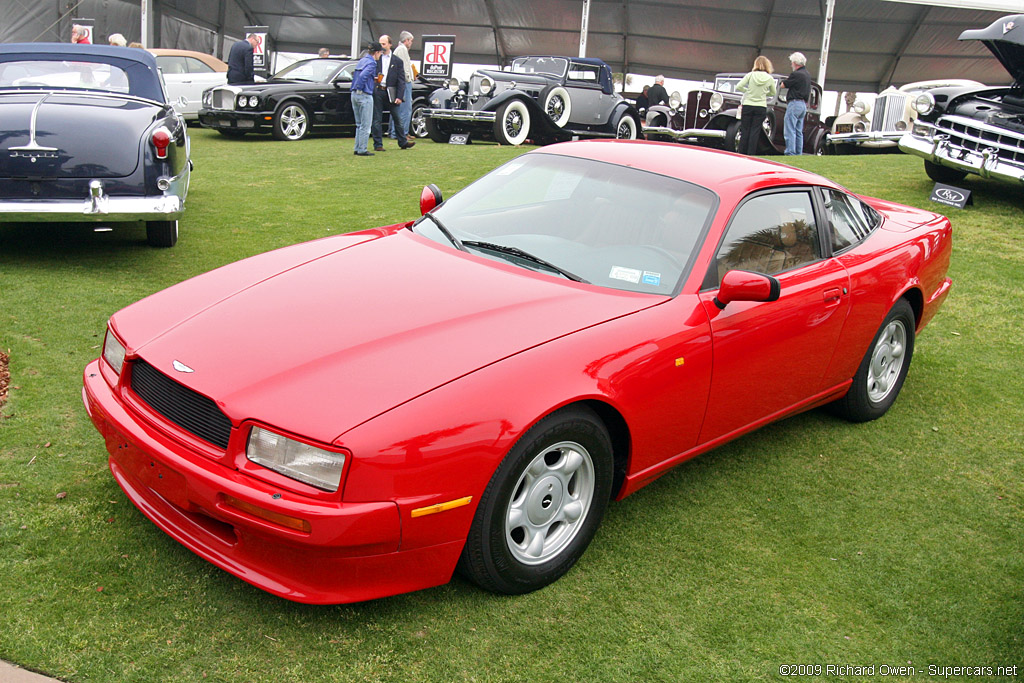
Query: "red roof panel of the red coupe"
529 140 843 199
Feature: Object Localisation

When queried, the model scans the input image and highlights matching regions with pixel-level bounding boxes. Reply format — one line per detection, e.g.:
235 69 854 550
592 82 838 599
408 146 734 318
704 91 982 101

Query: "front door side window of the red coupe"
706 191 821 286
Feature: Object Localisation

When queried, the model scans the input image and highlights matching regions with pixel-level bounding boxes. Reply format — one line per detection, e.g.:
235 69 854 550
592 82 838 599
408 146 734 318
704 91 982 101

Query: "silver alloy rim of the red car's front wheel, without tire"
505 441 596 565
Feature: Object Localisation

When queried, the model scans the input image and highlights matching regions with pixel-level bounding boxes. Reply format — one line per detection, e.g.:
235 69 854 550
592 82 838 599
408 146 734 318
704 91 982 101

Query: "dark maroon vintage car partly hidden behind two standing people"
644 74 827 155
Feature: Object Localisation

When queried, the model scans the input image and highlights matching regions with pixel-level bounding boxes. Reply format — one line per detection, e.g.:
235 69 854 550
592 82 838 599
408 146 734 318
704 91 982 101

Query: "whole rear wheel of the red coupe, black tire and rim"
829 299 916 422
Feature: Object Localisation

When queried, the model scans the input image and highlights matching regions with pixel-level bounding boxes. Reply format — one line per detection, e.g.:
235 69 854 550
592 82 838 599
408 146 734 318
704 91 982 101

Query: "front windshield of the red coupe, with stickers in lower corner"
414 154 718 295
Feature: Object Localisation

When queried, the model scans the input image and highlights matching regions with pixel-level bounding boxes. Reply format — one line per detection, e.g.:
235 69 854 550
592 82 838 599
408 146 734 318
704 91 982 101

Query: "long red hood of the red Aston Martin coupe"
114 229 664 442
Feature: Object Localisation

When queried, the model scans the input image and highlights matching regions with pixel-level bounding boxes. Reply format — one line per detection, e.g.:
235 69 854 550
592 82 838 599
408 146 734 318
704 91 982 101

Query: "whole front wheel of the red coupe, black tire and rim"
459 407 612 595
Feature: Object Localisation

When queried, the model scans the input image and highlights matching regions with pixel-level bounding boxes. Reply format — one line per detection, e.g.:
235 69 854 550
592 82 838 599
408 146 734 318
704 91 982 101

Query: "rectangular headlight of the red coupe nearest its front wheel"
246 427 345 490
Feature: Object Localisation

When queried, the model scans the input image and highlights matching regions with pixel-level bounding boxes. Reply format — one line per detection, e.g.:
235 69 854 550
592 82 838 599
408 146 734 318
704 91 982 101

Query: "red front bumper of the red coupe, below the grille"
82 359 463 604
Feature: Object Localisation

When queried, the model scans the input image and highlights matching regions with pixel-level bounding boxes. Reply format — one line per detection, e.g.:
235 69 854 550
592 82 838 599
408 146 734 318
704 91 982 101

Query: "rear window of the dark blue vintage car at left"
0 58 129 93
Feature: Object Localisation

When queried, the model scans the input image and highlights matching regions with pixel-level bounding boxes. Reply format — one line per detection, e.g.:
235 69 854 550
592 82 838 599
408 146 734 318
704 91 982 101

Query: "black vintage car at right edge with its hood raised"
899 14 1024 185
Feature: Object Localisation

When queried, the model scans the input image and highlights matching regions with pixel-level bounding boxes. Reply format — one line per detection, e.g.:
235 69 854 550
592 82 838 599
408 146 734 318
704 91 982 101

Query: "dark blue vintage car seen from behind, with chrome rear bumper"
0 43 191 247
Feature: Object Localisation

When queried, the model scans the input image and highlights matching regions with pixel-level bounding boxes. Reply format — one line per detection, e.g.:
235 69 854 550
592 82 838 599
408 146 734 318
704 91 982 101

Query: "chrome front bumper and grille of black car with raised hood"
899 117 1024 182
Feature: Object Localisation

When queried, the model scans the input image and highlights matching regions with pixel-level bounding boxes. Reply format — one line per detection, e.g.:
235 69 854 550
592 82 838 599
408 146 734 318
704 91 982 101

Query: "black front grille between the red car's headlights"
131 360 231 449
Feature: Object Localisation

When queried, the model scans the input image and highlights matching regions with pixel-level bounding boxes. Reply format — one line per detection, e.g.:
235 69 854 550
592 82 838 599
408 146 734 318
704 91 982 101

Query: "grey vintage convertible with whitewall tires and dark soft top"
424 56 640 144
